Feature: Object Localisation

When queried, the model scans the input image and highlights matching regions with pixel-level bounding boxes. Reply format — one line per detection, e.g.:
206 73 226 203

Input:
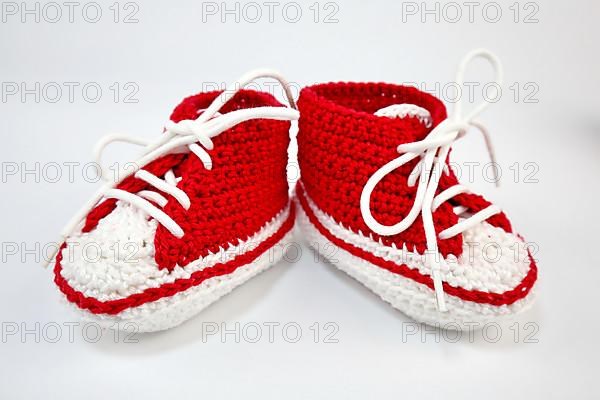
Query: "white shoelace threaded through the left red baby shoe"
46 70 299 265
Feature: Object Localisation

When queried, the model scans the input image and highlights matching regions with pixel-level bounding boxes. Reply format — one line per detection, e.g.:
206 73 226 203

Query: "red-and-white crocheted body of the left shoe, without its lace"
54 90 295 331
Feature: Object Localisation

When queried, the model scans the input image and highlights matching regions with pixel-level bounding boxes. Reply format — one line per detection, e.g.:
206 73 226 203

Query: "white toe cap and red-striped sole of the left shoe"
55 201 294 332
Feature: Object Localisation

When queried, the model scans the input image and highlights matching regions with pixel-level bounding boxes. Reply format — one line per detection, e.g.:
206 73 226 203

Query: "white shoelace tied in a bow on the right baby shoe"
360 49 502 312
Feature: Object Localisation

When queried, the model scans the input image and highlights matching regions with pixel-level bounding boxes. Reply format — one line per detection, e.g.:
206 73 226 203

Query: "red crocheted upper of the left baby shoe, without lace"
84 90 290 270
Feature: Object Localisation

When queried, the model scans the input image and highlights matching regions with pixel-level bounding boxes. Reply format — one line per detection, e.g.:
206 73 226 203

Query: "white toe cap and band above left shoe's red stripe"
60 201 290 301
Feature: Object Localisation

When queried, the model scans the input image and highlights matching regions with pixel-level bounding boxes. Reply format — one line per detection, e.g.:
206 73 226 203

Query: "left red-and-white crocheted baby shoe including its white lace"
48 71 298 332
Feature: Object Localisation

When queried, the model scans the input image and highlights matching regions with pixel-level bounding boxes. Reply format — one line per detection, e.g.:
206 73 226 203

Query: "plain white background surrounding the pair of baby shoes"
0 0 600 399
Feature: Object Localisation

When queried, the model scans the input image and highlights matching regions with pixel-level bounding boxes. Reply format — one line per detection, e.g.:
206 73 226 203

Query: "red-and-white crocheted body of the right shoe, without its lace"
297 82 537 323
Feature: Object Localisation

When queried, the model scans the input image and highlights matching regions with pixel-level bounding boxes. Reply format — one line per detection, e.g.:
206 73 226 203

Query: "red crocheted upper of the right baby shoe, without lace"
298 83 510 256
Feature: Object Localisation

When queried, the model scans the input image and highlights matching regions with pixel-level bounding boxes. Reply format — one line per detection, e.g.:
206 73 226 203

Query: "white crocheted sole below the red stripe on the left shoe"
62 229 293 332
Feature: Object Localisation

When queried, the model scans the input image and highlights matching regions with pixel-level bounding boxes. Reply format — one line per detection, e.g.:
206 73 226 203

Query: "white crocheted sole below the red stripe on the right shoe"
297 202 534 330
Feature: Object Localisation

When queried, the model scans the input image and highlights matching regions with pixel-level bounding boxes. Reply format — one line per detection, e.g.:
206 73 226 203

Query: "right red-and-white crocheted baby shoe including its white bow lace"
297 50 537 329
